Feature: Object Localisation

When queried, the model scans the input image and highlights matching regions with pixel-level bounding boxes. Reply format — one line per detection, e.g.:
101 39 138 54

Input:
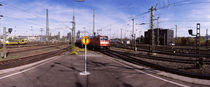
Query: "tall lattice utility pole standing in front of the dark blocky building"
149 6 156 53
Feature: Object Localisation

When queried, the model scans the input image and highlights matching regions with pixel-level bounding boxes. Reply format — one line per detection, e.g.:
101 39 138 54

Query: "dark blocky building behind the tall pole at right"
144 28 174 45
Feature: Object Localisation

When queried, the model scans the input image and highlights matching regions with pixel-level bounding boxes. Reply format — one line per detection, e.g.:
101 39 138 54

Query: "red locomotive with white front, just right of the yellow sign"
88 35 110 49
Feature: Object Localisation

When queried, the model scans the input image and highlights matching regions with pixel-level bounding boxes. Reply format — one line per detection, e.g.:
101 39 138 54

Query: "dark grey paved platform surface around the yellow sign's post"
0 51 208 87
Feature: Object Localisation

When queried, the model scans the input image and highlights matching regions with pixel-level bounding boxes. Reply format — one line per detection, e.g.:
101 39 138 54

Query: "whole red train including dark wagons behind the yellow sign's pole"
76 35 110 50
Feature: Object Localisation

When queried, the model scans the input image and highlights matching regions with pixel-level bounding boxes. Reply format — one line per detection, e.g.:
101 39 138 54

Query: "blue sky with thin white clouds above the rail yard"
0 0 210 38
